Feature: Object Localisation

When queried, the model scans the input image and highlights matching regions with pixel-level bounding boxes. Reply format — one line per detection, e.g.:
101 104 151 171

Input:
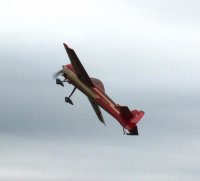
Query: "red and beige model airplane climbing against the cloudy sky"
54 44 144 135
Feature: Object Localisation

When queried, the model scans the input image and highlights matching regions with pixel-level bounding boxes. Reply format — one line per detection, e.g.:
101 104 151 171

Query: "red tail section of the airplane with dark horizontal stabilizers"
117 106 144 135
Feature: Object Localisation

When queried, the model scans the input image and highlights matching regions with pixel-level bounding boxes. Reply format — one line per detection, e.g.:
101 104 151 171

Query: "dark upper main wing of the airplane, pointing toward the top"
63 43 94 87
